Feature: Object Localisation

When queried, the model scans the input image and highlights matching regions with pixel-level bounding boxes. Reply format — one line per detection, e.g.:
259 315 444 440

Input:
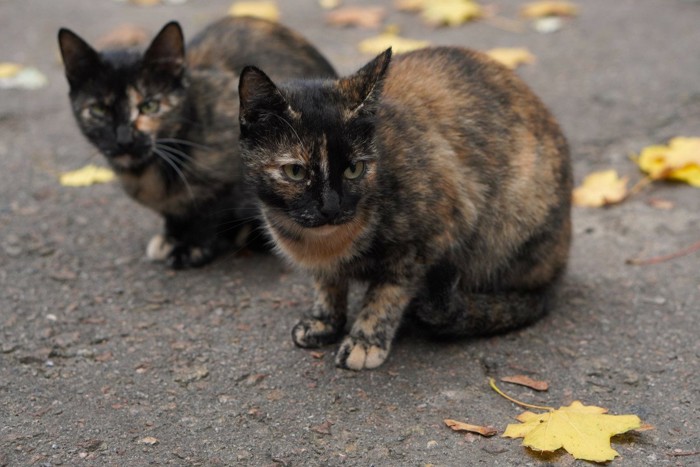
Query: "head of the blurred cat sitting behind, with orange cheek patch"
58 22 187 170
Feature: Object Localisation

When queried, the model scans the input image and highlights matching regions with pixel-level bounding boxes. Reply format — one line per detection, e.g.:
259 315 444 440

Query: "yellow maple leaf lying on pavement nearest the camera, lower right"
503 401 642 462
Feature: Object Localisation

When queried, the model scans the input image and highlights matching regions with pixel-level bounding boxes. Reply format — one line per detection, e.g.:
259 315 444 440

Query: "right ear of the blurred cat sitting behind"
143 21 185 77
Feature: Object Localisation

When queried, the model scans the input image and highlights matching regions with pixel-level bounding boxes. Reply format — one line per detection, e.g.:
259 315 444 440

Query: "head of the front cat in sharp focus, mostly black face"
239 49 391 231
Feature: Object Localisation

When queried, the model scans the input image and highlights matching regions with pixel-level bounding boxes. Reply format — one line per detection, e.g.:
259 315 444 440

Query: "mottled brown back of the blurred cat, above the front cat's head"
187 17 336 79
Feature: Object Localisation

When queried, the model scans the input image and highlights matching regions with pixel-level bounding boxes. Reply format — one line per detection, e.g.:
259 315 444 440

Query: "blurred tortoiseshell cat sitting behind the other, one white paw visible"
58 18 335 268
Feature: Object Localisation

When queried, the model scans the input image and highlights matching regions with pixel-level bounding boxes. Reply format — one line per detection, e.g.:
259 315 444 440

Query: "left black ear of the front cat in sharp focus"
238 66 289 126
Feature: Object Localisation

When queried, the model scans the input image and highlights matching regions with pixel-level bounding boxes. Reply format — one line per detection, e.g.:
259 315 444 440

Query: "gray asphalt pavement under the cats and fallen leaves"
0 0 700 466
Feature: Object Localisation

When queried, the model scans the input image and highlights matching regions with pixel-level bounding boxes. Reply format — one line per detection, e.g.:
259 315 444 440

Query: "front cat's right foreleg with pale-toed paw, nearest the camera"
335 284 410 370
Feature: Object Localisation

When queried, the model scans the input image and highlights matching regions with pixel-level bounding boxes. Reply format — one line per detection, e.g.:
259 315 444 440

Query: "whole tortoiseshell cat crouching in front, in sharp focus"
239 47 572 370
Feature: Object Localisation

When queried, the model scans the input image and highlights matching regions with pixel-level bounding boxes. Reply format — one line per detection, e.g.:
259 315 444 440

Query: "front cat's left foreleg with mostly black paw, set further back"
292 278 348 348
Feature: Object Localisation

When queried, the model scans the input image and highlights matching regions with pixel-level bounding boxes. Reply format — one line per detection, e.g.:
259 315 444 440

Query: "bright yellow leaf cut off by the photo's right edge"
637 137 700 187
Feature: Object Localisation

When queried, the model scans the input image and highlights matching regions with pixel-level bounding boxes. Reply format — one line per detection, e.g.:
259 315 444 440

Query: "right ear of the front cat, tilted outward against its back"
340 48 391 115
